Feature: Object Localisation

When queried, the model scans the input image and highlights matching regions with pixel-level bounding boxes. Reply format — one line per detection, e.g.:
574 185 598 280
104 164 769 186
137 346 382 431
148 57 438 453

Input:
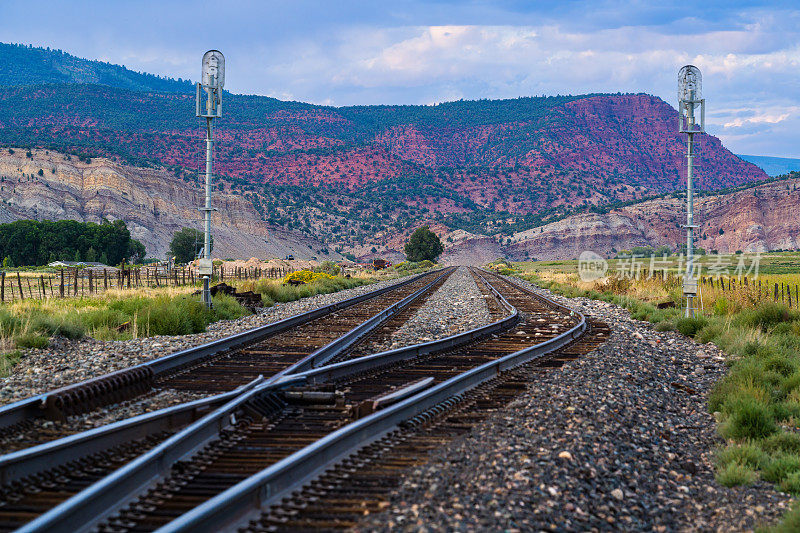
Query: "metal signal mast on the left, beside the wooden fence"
196 50 225 307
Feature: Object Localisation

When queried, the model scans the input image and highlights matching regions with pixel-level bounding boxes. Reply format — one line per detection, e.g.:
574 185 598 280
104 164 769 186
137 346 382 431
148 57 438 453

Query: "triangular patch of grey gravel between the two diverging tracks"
358 267 491 353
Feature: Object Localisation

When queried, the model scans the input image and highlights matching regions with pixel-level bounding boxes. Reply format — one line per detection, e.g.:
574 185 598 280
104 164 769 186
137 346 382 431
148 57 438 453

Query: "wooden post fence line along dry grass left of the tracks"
0 266 294 303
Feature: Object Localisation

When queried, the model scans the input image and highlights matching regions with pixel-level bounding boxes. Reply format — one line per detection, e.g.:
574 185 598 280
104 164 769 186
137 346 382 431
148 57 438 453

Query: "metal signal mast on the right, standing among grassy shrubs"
678 65 706 317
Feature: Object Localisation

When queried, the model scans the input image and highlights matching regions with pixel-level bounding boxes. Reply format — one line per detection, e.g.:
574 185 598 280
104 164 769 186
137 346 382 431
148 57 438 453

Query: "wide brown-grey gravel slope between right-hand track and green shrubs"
356 276 791 531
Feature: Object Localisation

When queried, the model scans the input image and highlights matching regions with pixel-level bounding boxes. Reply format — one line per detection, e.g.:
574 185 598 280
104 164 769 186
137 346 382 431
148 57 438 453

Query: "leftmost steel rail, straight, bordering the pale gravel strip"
0 271 436 428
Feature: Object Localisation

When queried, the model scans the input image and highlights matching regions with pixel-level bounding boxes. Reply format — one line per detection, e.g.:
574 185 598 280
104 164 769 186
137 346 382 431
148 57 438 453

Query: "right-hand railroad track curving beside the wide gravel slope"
0 268 607 531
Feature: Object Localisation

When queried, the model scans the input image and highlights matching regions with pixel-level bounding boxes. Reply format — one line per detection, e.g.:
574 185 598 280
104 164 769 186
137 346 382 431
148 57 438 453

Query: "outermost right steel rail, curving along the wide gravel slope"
153 272 587 533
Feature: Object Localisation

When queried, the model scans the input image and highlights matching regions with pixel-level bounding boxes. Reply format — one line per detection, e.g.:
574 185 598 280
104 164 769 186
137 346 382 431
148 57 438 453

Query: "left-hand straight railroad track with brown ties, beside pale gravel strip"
0 270 452 452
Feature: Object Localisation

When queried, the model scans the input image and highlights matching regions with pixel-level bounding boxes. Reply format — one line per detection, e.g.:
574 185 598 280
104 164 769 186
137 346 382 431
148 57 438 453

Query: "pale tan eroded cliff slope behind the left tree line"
0 148 341 259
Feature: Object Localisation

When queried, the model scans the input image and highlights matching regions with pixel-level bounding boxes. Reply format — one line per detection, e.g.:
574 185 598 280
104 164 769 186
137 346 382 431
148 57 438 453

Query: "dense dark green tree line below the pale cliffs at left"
0 220 145 267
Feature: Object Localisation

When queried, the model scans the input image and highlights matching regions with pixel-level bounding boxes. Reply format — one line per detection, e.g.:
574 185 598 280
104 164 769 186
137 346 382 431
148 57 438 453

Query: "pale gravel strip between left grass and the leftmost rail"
0 279 416 405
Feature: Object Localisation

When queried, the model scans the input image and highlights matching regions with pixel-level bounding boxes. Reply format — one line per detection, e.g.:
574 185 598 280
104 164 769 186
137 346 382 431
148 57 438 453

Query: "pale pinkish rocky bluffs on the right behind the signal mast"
503 176 800 259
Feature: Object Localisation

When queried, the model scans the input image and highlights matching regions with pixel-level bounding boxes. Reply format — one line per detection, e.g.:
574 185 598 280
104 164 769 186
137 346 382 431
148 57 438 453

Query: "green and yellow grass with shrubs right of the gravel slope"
494 253 800 531
